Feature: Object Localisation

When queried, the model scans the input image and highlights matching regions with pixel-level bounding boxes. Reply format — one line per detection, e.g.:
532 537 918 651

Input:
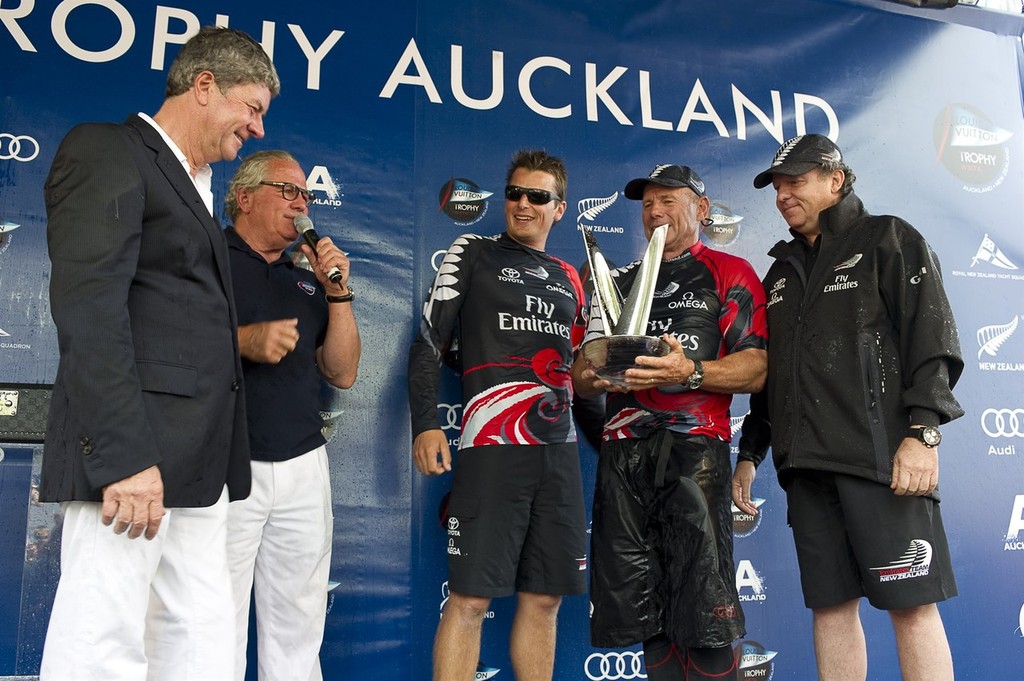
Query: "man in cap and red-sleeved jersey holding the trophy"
573 165 767 681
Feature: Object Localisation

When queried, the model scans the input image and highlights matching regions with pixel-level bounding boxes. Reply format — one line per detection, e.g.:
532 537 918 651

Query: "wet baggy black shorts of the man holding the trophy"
590 430 744 648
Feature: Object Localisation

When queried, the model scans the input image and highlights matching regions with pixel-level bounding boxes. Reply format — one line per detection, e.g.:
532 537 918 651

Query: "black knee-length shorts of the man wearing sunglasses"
446 443 587 598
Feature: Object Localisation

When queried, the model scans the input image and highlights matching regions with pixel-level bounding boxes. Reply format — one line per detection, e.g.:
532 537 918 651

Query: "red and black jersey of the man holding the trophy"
587 242 768 440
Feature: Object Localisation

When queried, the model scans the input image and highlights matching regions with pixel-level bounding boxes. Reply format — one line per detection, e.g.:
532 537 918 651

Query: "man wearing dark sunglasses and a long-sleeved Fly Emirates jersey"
409 151 587 681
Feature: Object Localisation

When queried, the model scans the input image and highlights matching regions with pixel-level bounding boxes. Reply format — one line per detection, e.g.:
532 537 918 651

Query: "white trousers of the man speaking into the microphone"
227 446 334 681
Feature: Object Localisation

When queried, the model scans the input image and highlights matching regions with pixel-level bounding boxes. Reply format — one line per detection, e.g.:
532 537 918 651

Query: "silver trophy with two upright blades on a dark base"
581 224 669 385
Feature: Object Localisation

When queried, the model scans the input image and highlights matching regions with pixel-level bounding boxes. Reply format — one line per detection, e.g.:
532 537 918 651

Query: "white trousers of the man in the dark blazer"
39 491 236 681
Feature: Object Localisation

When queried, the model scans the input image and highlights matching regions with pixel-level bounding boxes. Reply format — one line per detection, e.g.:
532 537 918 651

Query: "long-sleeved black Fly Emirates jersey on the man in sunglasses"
409 233 586 450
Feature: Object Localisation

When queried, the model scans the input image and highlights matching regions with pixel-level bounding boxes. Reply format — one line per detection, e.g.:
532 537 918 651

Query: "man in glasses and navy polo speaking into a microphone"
224 151 359 681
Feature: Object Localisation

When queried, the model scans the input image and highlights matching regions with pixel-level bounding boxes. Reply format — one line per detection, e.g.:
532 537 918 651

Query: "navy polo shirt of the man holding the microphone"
224 227 328 461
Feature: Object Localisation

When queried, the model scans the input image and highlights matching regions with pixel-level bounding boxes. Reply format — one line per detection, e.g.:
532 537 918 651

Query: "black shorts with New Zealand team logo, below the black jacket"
785 471 956 610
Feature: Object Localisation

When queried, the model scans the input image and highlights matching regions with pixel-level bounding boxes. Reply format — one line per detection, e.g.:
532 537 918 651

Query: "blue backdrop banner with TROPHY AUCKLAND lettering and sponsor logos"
0 0 1024 681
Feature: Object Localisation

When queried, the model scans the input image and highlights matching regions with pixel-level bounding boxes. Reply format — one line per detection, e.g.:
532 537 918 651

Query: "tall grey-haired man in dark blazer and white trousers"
40 28 281 680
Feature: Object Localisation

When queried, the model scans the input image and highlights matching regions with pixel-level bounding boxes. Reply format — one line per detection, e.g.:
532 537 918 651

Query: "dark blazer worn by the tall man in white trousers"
41 116 250 507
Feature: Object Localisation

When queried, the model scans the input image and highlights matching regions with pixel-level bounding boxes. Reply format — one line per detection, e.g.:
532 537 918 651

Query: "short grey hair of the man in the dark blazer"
164 26 281 97
